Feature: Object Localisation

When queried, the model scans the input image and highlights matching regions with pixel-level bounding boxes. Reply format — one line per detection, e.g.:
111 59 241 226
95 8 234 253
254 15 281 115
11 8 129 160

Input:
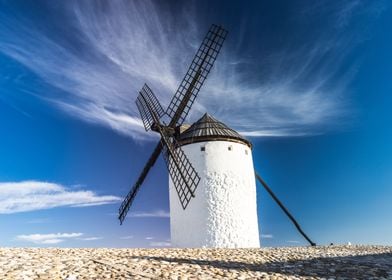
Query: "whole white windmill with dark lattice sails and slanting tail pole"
119 25 314 247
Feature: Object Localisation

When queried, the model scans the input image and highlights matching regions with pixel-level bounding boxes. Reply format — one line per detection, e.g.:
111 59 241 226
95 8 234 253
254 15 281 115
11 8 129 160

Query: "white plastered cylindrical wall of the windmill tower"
169 141 260 248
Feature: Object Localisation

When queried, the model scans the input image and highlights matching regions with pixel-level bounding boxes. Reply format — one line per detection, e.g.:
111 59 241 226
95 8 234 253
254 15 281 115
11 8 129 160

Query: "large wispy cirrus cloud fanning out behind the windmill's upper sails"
0 0 386 139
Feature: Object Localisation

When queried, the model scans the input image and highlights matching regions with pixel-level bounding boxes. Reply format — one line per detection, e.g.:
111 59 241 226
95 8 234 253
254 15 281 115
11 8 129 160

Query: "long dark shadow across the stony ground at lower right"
132 253 392 279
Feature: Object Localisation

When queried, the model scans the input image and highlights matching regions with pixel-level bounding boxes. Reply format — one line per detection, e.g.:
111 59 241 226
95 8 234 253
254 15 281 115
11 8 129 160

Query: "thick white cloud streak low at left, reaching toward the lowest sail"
0 181 121 214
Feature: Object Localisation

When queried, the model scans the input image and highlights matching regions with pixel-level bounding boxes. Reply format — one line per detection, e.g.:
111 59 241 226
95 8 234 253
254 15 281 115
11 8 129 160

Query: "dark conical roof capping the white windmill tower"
178 113 252 147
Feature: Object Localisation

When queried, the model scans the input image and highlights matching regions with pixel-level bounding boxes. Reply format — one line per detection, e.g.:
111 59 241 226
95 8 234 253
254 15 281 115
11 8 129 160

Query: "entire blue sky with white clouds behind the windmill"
0 0 392 247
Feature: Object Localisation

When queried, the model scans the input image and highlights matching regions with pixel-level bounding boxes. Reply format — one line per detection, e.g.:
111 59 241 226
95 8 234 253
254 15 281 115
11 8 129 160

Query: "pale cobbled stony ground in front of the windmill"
0 245 392 280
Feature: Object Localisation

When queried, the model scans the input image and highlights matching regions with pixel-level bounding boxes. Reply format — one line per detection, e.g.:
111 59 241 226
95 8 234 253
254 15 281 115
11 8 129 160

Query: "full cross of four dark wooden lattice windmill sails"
118 25 227 224
